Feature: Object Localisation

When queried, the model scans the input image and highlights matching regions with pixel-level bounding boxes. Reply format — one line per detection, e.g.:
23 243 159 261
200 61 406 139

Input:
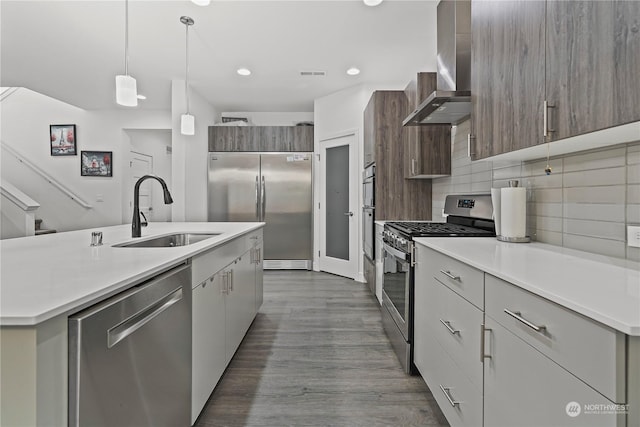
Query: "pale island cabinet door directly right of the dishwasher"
191 272 227 424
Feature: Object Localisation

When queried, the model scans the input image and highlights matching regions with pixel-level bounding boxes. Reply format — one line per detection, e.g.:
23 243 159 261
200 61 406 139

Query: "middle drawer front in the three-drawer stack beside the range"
431 278 483 389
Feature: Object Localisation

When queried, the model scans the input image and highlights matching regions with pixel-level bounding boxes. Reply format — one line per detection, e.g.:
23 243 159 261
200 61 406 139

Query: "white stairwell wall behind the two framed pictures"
0 88 171 231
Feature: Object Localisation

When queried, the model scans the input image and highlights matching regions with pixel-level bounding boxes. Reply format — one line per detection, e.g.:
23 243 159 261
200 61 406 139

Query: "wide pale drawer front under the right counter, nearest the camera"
485 274 626 403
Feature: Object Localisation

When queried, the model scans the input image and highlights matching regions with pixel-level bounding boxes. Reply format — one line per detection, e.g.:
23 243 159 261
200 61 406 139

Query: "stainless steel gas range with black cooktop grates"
381 194 495 374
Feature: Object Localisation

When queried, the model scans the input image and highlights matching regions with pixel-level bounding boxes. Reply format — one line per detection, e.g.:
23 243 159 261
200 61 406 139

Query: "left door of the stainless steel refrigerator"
208 153 260 222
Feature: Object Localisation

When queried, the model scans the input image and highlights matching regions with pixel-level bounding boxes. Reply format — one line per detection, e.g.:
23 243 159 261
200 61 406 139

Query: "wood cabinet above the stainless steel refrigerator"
209 126 313 152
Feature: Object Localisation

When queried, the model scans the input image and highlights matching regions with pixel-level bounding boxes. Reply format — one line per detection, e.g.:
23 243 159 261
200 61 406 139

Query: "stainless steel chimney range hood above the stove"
402 0 471 126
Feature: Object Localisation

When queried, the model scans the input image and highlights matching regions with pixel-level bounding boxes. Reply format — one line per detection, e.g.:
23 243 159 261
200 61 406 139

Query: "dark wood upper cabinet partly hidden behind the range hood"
404 73 451 178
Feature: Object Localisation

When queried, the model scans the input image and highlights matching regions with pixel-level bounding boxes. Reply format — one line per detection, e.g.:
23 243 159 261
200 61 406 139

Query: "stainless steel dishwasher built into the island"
69 264 191 427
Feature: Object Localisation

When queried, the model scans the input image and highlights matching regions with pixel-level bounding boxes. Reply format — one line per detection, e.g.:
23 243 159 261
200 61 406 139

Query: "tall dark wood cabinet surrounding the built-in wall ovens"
363 91 431 220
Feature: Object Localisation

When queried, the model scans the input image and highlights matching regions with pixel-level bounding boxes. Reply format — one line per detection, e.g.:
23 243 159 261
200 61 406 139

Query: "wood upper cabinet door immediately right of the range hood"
471 0 545 160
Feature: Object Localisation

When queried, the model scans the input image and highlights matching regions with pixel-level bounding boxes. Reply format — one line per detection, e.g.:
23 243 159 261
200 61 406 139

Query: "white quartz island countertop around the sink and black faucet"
0 222 264 326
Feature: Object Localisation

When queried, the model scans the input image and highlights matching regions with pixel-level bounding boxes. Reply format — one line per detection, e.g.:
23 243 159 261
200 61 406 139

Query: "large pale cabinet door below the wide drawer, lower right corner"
484 318 625 427
